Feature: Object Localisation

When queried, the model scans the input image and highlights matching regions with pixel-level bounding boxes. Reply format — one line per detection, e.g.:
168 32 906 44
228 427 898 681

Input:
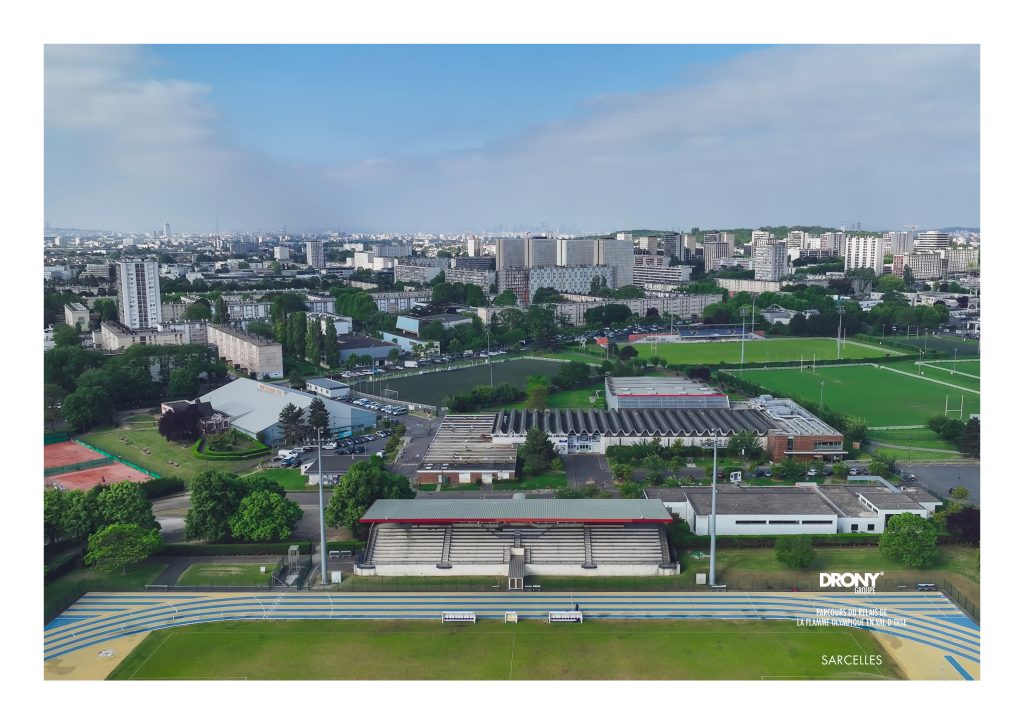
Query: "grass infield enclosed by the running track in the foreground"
110 621 903 680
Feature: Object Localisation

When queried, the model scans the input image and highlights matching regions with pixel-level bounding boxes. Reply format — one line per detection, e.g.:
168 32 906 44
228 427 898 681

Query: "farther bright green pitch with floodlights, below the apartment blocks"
633 337 906 365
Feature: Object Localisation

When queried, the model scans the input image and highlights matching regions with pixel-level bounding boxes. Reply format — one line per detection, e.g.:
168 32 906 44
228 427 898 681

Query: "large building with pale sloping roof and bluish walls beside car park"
200 378 377 446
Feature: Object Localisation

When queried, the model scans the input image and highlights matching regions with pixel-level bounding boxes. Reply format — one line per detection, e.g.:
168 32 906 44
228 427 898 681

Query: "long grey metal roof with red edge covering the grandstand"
359 498 672 523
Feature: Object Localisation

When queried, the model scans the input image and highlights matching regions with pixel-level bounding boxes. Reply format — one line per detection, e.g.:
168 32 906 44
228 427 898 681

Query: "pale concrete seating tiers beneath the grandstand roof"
359 523 675 568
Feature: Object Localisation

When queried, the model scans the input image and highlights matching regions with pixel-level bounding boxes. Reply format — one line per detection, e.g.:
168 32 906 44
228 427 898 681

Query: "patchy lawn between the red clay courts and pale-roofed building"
79 419 272 479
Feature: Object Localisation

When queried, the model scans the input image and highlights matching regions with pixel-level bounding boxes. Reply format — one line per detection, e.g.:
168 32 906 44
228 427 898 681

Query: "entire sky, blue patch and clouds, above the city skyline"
43 45 980 233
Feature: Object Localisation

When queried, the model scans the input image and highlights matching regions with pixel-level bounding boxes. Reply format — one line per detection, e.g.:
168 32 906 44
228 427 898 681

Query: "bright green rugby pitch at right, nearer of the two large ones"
734 365 981 426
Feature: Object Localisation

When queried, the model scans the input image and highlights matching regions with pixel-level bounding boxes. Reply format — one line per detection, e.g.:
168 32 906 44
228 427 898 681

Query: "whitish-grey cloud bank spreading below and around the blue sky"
46 46 979 229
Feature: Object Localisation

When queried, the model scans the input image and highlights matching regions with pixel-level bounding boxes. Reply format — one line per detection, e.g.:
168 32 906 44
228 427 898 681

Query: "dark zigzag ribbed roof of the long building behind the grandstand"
494 409 775 436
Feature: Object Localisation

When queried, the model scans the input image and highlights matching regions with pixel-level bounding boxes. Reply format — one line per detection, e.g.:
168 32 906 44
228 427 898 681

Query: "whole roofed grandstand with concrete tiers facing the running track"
355 494 679 590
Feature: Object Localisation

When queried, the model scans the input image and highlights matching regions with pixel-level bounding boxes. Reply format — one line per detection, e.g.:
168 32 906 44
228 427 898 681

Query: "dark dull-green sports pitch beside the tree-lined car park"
353 358 561 404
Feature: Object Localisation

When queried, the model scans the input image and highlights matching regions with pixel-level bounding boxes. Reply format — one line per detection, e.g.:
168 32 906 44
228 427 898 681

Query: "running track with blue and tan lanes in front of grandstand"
44 591 981 678
